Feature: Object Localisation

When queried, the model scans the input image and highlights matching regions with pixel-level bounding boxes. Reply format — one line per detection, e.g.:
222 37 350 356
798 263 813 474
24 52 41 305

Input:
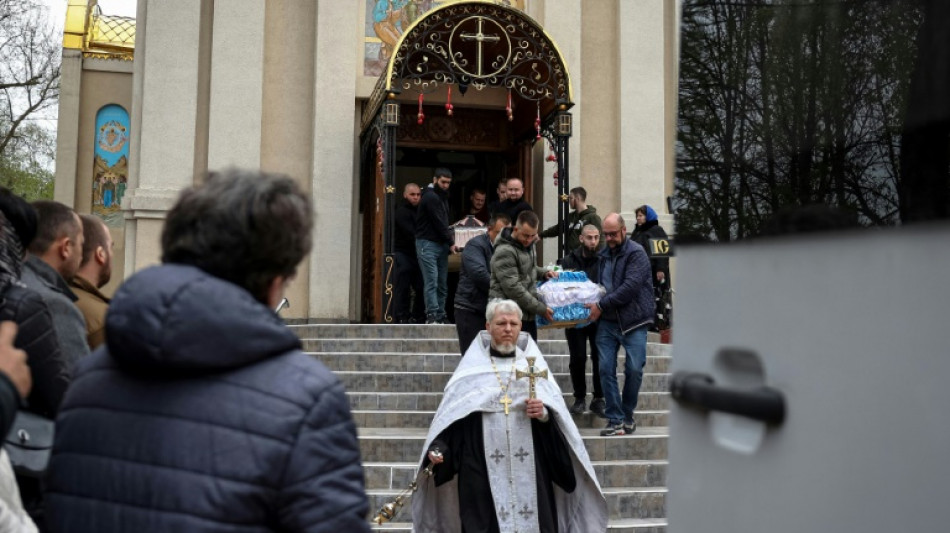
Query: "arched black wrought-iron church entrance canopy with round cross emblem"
360 1 573 323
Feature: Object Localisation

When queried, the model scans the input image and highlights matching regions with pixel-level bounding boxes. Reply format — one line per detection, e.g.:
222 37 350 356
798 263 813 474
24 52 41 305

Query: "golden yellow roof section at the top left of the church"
63 0 135 61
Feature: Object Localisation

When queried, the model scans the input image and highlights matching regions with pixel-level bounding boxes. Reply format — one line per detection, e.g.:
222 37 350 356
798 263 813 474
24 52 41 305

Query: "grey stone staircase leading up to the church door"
291 324 671 533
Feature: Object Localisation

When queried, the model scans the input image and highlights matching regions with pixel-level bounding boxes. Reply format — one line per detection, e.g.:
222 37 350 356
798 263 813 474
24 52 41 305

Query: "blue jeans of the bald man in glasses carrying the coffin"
596 320 648 425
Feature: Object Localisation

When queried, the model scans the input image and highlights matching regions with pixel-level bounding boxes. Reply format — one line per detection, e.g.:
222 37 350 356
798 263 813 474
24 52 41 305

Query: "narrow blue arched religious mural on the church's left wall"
92 104 129 227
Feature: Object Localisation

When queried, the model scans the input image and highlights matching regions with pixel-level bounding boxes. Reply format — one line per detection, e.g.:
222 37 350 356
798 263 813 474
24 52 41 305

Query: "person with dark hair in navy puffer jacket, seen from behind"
47 170 369 533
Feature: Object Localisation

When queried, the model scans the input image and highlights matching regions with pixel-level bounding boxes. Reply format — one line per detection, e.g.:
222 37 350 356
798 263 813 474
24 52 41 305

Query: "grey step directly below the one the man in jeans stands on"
363 460 668 492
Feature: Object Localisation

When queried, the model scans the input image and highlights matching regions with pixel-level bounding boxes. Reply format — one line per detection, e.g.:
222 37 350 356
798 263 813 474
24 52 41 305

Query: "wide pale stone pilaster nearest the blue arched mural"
125 0 212 275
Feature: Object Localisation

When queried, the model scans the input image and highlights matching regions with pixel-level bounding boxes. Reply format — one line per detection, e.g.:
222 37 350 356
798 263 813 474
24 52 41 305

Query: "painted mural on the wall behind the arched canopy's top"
363 0 527 78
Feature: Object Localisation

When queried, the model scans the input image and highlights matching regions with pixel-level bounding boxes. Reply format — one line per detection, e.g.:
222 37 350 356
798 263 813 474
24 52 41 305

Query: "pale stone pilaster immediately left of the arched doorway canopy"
309 2 360 321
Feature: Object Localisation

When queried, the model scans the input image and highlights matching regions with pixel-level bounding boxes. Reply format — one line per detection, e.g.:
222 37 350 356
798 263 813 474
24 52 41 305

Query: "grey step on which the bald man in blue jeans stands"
359 427 667 462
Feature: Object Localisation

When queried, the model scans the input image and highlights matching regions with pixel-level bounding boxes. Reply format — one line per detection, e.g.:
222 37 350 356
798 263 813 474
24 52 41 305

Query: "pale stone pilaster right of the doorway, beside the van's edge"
616 0 675 229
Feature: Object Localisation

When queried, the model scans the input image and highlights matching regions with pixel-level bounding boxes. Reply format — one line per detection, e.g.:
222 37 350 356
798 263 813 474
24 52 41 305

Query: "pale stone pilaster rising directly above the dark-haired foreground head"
208 0 266 170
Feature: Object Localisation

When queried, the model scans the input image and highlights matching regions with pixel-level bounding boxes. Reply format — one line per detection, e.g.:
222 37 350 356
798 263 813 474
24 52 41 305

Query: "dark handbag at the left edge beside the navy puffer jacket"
3 411 55 478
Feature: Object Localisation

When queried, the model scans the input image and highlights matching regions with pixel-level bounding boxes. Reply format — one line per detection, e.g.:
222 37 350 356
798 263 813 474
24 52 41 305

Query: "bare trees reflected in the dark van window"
674 0 924 241
